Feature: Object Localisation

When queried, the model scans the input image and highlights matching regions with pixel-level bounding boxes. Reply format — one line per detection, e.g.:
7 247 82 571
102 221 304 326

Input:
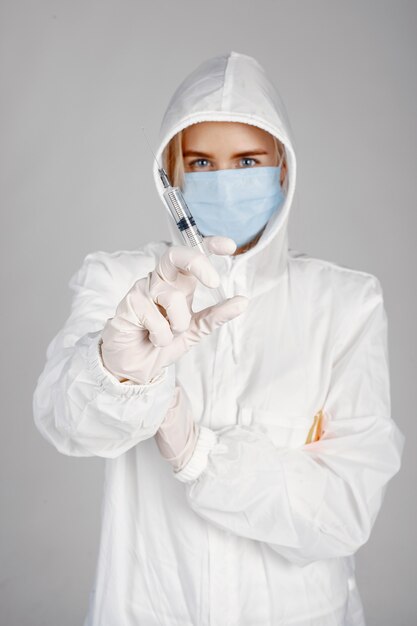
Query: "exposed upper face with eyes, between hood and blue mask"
182 122 285 184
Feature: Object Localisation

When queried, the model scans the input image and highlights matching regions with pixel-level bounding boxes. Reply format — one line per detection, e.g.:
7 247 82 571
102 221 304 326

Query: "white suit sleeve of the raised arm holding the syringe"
33 252 175 458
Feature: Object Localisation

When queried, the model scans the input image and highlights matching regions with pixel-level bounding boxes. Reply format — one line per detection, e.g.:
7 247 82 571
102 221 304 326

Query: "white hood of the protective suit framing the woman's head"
153 51 296 297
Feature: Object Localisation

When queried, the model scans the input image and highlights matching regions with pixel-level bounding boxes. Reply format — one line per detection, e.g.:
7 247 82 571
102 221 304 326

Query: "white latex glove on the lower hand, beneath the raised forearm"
154 386 198 472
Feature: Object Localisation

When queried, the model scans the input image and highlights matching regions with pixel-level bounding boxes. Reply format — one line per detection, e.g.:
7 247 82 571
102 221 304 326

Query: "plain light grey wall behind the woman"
0 0 417 626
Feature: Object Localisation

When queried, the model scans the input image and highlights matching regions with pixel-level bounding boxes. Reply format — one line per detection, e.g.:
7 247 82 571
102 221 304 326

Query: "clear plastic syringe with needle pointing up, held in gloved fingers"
142 127 227 304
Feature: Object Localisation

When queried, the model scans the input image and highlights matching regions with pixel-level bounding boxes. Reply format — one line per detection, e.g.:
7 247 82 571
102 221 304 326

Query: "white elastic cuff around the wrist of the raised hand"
87 331 167 397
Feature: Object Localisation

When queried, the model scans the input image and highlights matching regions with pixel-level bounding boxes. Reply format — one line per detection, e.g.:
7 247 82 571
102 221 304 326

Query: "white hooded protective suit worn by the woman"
33 52 404 626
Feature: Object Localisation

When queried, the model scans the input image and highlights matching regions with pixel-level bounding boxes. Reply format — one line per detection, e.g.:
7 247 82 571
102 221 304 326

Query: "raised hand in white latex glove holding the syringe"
101 236 249 384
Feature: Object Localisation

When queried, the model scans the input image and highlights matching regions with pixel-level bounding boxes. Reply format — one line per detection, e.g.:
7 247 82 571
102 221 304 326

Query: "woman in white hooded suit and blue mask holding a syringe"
34 52 404 626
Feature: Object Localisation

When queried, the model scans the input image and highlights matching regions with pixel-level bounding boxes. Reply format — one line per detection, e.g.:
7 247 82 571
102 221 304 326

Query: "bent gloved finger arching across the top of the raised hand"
155 246 220 287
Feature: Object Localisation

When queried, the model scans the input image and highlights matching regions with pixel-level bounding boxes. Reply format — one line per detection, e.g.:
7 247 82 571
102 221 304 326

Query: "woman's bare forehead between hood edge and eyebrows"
182 122 273 149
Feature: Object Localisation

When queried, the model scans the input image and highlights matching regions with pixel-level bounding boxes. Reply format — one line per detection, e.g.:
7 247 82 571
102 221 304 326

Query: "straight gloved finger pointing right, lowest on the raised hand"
171 296 249 354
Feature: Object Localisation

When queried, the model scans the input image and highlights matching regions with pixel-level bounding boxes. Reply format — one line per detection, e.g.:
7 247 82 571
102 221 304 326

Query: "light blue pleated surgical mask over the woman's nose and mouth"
183 166 284 248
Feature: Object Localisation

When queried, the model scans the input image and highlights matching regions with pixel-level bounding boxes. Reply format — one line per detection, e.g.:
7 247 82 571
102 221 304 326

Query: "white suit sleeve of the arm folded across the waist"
174 276 404 566
